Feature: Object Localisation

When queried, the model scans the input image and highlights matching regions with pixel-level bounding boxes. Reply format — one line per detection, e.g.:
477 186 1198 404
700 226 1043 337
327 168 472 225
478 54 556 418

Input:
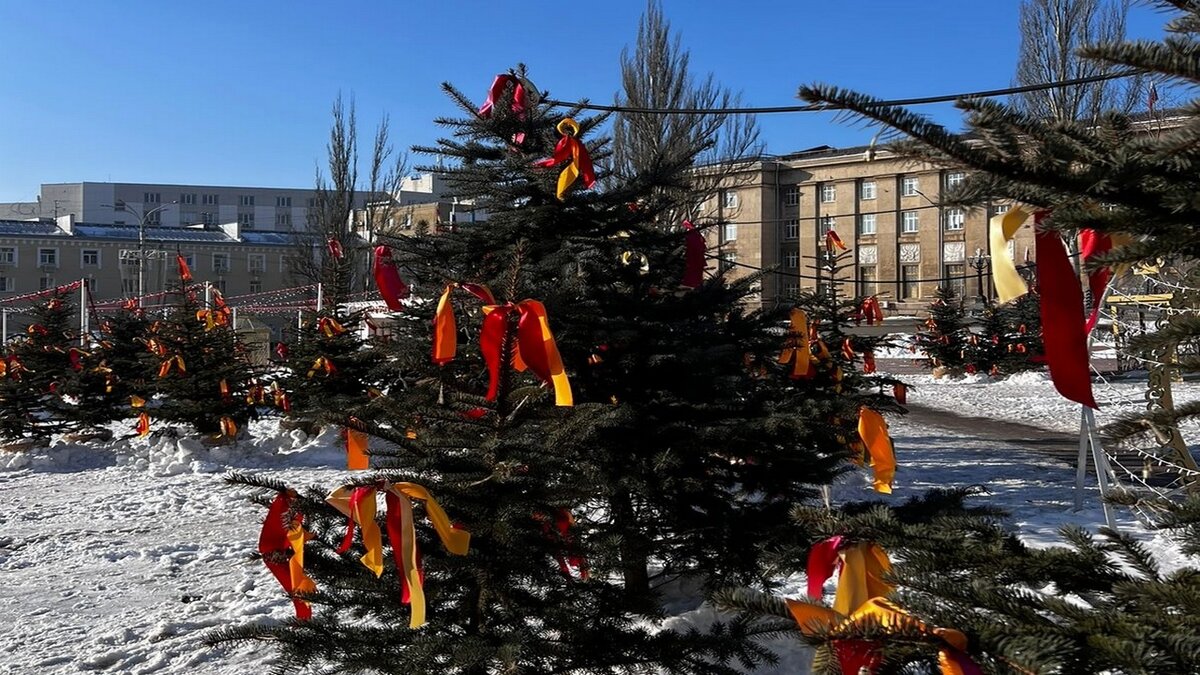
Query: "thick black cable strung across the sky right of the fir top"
544 68 1141 115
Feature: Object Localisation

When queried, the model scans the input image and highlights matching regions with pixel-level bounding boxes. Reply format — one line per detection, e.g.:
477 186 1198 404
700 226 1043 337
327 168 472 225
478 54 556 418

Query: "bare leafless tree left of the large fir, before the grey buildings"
288 95 406 304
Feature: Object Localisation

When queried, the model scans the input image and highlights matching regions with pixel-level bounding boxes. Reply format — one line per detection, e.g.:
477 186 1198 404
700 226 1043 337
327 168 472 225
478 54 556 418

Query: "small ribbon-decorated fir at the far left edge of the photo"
0 288 80 438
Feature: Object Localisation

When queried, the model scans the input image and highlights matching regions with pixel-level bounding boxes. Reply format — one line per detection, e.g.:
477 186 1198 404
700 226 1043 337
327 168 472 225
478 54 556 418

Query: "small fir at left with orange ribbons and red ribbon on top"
143 286 254 438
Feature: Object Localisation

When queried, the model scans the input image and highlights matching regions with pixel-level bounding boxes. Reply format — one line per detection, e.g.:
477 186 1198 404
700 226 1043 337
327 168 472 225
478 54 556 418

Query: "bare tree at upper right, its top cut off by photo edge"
1014 0 1142 121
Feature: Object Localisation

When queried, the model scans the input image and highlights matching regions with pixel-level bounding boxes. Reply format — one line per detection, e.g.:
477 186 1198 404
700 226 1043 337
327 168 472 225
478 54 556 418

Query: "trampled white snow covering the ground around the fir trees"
0 376 1200 675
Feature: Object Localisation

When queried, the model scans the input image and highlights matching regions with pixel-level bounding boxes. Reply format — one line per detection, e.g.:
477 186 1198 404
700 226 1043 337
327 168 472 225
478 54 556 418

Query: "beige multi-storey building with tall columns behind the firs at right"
700 147 1033 312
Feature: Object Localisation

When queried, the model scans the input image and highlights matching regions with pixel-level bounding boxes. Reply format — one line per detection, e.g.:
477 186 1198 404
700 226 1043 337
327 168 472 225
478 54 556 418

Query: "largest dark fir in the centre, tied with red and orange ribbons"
211 65 890 674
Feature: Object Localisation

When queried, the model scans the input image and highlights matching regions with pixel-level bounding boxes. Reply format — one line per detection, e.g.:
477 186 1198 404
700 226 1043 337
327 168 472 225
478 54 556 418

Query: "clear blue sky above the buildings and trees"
0 0 1163 202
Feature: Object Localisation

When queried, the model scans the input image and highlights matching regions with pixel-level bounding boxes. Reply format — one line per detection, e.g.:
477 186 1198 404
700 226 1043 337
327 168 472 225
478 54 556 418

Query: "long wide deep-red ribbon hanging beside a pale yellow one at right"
1034 218 1099 408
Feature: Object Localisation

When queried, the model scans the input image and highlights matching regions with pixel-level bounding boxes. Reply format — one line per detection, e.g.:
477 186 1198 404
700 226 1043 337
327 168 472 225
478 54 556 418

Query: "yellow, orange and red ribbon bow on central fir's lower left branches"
325 482 470 628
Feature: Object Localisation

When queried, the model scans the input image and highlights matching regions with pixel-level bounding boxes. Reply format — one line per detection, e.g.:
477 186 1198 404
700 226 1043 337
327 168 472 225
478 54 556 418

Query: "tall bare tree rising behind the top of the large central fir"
613 0 763 217
